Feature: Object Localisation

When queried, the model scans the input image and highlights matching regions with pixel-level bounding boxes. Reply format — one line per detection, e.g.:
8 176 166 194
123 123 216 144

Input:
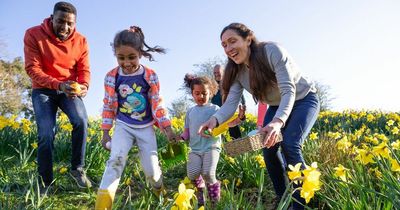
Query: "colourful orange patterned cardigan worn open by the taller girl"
101 66 171 130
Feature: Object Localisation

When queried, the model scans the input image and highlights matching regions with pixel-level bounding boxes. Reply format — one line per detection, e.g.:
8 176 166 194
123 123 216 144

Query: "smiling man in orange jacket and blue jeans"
24 2 91 194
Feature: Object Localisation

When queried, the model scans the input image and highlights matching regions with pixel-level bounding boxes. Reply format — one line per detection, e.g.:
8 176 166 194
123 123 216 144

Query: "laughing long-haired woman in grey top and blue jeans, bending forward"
199 23 320 209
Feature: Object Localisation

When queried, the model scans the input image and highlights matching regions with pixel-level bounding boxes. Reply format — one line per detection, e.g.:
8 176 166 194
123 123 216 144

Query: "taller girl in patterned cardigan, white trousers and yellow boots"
96 26 175 209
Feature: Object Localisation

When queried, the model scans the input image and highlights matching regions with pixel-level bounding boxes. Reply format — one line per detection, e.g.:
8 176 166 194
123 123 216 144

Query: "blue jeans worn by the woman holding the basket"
263 93 320 209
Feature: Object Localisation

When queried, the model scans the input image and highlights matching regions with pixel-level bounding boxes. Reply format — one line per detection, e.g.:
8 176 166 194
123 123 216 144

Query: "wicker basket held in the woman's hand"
224 133 282 157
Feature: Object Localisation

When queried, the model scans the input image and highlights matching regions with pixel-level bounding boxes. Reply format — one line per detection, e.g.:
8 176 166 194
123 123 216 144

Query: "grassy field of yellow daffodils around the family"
0 111 400 209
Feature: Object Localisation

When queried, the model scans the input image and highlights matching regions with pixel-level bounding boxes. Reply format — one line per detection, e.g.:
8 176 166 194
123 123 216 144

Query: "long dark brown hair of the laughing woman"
220 23 277 102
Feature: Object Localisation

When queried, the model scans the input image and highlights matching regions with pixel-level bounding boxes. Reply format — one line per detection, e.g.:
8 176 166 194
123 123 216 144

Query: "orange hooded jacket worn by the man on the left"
24 18 90 90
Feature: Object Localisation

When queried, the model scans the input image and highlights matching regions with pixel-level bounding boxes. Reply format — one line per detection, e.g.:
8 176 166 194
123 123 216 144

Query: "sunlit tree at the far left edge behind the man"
0 57 33 118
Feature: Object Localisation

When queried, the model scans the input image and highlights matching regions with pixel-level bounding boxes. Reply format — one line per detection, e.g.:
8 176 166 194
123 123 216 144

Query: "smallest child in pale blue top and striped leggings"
181 74 244 206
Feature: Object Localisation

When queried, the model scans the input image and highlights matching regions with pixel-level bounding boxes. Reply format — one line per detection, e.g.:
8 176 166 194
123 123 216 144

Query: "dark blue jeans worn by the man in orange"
32 89 88 185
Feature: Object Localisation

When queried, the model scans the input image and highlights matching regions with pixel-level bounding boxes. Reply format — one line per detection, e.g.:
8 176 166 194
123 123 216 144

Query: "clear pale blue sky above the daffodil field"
0 0 400 116
